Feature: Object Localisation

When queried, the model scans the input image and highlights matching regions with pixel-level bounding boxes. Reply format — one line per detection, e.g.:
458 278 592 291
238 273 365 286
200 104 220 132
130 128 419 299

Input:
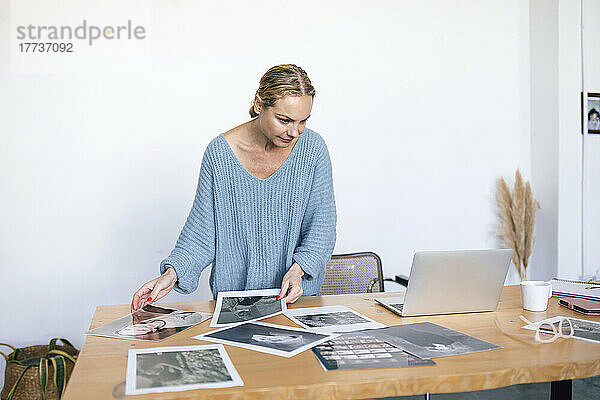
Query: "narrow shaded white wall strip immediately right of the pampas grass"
528 0 559 279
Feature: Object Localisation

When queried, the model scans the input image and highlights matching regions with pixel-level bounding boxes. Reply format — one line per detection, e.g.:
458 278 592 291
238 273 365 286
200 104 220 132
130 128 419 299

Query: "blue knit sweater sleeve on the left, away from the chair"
160 147 215 294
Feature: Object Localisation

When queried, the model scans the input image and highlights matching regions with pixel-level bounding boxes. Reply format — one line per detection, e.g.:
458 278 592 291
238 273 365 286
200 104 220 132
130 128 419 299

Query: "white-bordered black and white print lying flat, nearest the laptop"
284 306 386 333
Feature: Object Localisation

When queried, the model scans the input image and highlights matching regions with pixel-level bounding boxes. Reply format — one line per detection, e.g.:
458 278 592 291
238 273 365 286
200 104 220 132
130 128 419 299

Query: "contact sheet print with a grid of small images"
312 332 435 371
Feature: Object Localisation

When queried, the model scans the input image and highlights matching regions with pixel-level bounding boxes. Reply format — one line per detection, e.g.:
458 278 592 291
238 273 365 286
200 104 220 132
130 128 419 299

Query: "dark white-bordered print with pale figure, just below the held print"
194 322 339 357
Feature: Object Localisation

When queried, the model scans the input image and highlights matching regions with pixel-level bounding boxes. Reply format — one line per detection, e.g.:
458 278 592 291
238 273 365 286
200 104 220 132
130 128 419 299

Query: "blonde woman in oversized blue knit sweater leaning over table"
131 64 336 312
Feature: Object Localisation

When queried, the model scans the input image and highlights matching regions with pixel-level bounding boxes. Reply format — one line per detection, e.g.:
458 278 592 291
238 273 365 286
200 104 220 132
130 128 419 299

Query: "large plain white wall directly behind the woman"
0 0 546 390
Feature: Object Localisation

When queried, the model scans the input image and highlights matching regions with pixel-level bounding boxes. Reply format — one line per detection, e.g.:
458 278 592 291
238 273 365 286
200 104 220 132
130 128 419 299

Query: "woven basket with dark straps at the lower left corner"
0 343 79 400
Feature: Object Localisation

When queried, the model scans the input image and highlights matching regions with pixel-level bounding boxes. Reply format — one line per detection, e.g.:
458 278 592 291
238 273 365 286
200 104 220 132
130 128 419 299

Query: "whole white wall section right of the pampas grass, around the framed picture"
530 0 600 279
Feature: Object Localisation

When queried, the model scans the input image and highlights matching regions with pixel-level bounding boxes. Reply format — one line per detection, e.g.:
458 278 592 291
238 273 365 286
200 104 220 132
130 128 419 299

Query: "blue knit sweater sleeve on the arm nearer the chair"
293 143 336 279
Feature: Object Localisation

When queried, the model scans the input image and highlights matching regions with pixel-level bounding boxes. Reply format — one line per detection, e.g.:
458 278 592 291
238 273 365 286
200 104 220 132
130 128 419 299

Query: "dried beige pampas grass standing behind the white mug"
496 169 540 280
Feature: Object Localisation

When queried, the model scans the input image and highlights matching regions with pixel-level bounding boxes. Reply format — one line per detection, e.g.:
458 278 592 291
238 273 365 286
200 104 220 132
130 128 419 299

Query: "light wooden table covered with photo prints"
63 286 600 400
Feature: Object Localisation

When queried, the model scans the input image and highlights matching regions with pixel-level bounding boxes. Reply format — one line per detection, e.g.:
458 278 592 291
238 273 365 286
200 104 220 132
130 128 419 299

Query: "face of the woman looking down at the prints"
255 95 313 148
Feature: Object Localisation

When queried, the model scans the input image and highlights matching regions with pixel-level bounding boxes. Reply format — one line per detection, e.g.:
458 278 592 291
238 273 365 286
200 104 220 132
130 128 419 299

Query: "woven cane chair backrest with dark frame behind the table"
321 252 383 294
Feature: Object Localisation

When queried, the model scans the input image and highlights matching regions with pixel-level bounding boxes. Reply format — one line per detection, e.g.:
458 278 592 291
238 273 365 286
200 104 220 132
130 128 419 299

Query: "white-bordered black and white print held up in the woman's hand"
210 289 287 328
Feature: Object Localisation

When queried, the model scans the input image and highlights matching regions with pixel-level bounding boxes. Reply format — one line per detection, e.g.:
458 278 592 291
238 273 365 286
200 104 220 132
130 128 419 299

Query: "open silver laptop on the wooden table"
375 249 513 317
